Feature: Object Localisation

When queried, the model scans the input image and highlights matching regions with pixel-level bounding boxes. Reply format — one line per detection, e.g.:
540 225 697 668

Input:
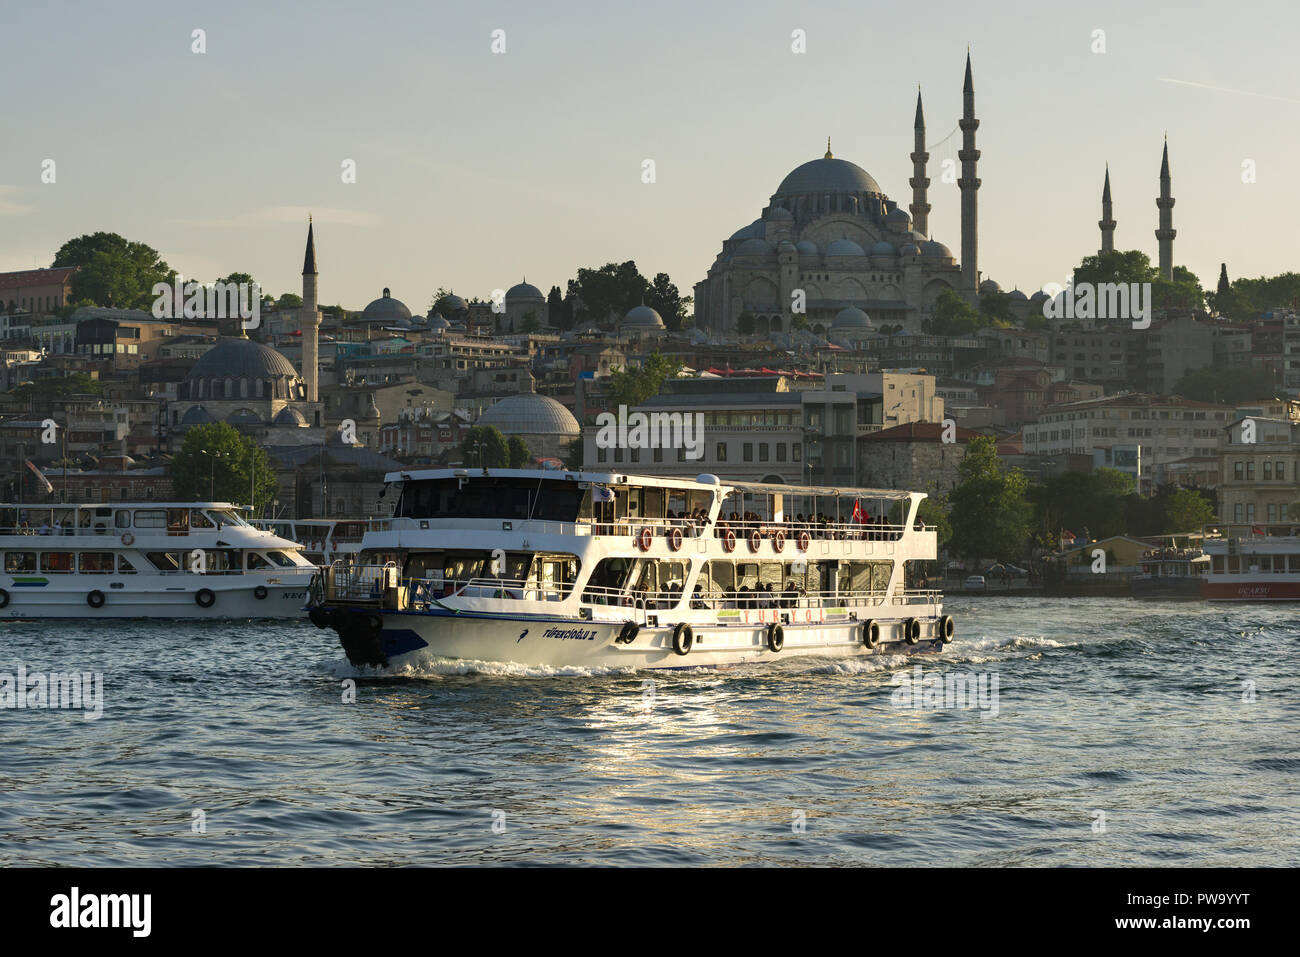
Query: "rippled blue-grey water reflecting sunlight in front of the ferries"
0 598 1300 866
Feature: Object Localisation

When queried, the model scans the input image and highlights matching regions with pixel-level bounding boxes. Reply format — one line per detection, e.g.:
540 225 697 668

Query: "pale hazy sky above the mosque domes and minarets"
0 0 1300 312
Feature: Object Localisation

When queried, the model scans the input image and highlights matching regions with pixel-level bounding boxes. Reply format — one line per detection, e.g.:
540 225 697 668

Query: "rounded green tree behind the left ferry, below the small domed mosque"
172 423 278 510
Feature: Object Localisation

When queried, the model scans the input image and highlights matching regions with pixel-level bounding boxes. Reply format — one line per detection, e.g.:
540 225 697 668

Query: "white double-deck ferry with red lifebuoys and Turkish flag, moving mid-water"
309 469 954 668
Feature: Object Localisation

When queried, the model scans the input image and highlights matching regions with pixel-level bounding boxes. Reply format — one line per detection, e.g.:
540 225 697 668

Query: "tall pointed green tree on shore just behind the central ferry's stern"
948 436 1032 562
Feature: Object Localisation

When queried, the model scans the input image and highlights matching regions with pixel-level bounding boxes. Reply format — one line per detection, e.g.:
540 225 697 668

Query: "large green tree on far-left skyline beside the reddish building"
53 233 176 308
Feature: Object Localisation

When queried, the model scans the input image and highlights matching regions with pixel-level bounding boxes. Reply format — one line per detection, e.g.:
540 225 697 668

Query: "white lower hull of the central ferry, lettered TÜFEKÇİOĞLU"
312 607 944 670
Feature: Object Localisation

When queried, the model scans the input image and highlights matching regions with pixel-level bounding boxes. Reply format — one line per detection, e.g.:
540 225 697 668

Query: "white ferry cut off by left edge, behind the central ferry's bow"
0 502 316 619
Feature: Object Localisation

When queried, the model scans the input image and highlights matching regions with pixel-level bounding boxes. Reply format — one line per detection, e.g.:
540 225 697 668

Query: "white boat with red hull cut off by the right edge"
1204 524 1300 602
